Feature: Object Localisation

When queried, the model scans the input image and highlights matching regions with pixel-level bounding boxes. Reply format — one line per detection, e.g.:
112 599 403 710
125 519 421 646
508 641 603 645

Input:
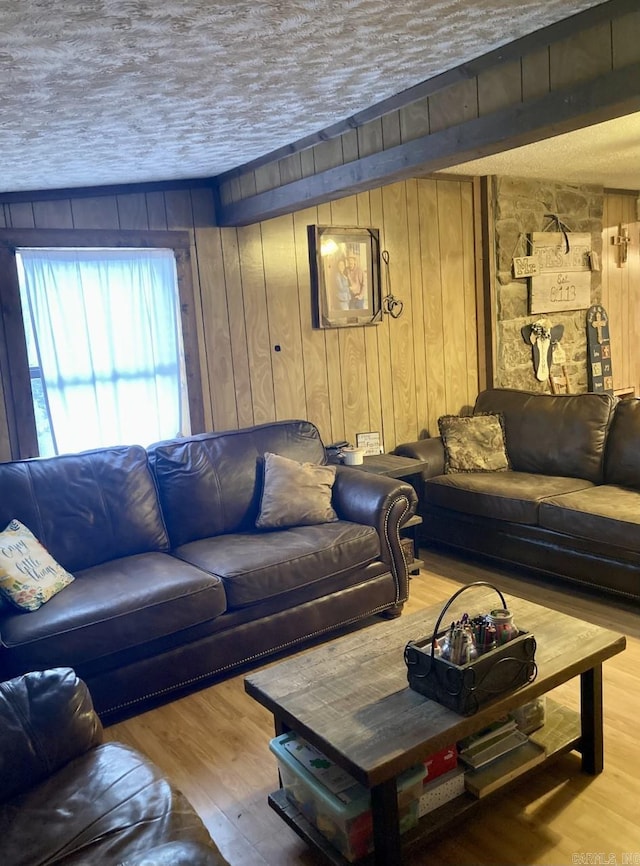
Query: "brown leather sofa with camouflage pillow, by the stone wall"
396 388 640 600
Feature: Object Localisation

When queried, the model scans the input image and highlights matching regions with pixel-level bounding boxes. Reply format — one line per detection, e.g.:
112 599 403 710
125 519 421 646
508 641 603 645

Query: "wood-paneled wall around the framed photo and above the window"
0 179 485 459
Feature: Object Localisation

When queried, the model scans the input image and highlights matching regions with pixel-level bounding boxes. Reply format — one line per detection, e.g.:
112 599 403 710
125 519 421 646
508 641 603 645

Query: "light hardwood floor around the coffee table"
106 550 640 866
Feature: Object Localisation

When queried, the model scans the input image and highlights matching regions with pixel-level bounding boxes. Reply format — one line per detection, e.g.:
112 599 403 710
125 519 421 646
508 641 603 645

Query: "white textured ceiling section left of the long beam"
0 0 620 192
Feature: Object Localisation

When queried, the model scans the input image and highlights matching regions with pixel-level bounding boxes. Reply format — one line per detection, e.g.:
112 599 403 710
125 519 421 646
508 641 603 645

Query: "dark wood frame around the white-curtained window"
0 229 204 460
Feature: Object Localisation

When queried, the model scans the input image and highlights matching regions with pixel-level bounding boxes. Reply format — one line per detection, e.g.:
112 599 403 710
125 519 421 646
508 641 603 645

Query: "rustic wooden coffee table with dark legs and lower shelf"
245 587 626 866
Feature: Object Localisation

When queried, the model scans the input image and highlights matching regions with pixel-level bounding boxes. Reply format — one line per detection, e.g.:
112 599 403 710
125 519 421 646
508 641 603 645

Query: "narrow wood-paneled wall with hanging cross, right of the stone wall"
602 193 640 397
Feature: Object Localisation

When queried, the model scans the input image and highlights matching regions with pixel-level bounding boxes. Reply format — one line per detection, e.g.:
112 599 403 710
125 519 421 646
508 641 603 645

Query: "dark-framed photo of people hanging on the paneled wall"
307 226 382 328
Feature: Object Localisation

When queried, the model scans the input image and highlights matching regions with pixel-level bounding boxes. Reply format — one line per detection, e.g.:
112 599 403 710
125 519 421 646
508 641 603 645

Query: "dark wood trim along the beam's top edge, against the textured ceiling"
215 0 638 184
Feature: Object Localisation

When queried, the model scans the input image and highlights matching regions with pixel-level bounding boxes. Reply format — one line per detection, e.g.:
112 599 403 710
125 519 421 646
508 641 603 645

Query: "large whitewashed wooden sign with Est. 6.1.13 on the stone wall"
529 232 591 313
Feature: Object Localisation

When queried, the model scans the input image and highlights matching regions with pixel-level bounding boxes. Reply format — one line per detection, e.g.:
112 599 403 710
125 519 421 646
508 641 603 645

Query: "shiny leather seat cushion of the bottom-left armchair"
0 743 215 866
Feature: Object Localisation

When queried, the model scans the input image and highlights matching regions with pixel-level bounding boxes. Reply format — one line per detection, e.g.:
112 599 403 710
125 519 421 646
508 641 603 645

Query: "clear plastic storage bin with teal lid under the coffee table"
269 732 424 863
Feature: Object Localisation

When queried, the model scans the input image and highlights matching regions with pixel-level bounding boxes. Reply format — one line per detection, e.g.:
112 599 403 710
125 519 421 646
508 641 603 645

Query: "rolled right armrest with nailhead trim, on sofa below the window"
333 466 418 601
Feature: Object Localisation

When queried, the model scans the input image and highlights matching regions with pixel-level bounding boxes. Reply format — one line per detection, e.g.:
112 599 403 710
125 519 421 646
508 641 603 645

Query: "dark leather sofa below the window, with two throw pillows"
0 421 417 722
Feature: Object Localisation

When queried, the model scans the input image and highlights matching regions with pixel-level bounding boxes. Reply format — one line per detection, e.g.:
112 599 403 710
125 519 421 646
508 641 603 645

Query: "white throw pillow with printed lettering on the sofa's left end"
0 520 74 610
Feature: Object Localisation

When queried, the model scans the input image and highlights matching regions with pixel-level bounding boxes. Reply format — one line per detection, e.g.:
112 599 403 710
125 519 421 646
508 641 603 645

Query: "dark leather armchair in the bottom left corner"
0 668 228 866
